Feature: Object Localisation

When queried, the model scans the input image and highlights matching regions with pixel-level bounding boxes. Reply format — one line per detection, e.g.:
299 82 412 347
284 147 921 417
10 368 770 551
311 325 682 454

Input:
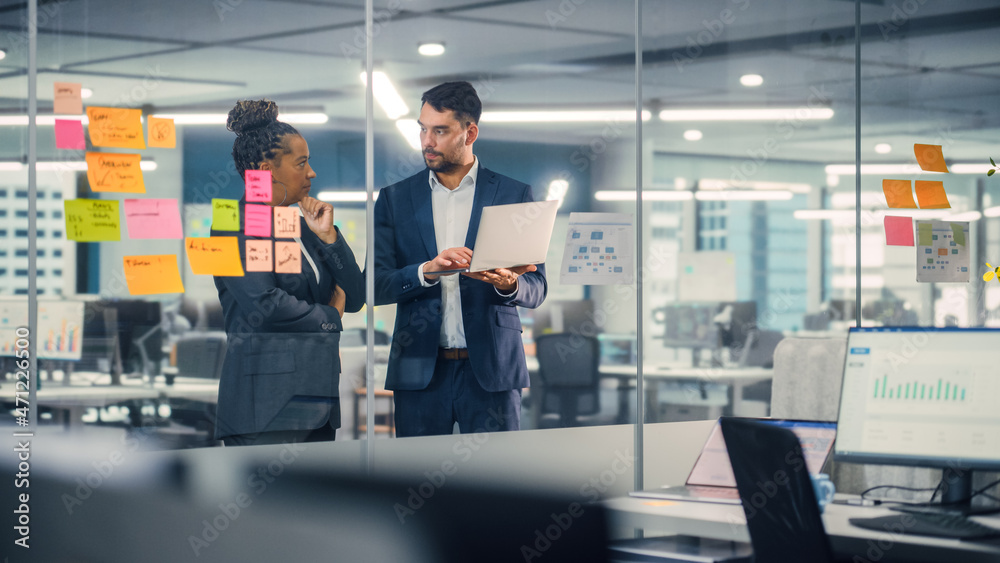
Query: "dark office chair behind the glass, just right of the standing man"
535 333 601 427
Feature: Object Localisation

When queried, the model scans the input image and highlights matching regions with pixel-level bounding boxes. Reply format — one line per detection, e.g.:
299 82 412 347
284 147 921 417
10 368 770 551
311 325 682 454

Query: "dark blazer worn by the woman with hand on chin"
212 200 365 438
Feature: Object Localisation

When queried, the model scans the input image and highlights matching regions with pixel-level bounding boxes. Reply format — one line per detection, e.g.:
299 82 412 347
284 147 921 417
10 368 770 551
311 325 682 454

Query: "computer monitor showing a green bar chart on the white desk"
834 327 1000 509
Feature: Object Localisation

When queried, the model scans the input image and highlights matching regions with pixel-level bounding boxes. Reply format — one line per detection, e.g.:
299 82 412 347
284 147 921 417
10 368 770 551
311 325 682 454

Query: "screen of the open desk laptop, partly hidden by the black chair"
687 418 837 487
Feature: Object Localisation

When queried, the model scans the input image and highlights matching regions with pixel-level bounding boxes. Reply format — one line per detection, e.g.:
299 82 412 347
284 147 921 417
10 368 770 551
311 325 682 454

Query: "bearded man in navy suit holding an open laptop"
375 82 548 437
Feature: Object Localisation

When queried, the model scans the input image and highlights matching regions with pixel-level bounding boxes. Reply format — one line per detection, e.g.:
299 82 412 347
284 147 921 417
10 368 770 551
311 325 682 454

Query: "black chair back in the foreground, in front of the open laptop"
719 417 833 563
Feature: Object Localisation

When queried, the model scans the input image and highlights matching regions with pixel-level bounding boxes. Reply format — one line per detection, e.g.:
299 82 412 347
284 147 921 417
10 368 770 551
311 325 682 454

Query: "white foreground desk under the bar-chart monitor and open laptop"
604 495 1000 563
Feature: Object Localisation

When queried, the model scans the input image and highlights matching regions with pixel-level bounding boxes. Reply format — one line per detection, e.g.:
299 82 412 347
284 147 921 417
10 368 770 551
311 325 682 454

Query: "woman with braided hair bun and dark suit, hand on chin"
212 100 364 446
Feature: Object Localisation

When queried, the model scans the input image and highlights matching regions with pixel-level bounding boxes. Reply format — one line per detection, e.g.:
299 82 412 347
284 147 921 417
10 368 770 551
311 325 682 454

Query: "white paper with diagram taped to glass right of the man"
559 213 634 285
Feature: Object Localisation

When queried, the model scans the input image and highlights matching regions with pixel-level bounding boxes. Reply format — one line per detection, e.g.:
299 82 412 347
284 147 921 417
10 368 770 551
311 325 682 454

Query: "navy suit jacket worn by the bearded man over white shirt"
375 166 548 391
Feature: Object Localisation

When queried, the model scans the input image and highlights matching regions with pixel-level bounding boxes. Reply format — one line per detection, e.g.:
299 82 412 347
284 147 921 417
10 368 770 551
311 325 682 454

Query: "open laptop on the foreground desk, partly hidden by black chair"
629 418 837 504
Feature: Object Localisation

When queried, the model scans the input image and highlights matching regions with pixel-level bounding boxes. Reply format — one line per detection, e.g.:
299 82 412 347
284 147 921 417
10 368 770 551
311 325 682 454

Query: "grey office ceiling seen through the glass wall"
0 0 1000 167
